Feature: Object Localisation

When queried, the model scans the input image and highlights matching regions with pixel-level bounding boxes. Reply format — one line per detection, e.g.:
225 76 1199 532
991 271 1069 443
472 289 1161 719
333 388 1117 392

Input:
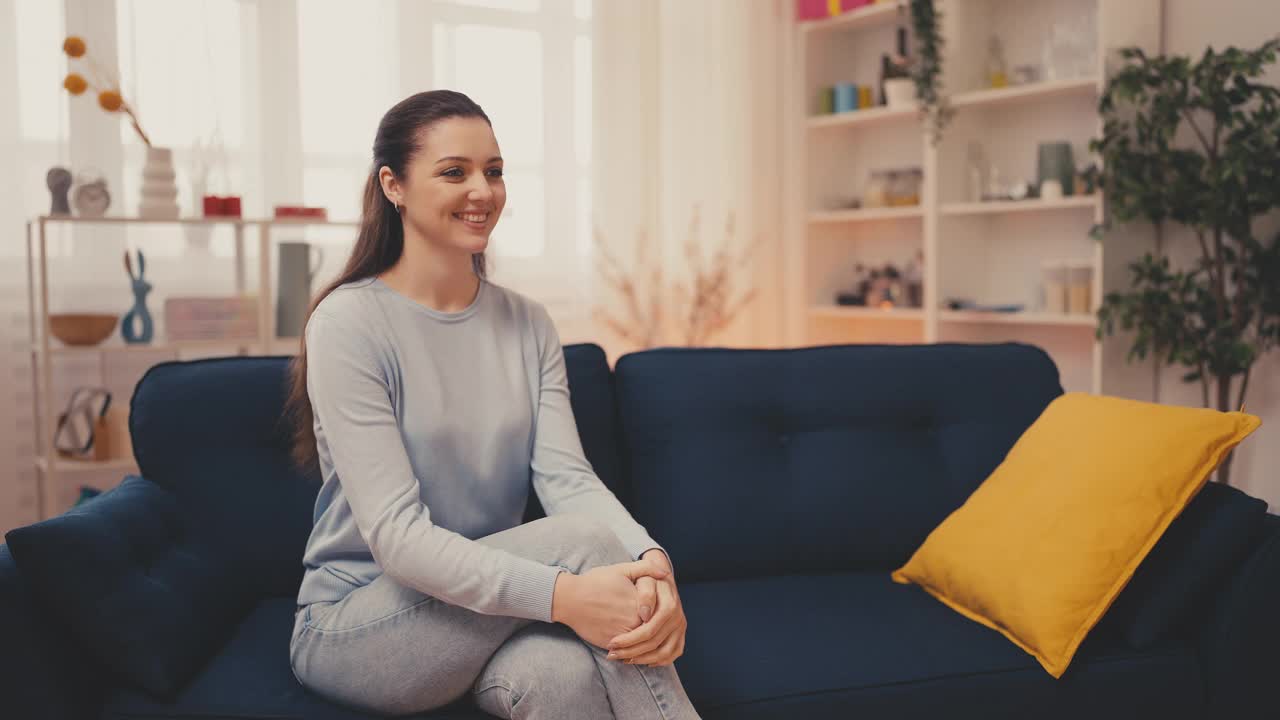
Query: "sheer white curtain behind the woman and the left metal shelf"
0 0 594 532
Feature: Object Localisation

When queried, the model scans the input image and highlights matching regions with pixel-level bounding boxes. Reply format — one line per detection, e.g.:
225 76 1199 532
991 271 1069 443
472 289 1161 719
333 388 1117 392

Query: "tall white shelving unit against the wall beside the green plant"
785 0 1161 393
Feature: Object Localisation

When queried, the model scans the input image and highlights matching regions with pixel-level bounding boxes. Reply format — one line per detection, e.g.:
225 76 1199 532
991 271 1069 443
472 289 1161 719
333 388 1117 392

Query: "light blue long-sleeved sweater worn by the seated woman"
298 278 666 621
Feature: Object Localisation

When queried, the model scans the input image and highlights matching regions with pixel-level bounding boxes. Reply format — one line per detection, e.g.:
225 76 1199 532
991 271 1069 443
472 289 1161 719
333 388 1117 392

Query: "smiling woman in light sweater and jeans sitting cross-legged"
289 91 698 720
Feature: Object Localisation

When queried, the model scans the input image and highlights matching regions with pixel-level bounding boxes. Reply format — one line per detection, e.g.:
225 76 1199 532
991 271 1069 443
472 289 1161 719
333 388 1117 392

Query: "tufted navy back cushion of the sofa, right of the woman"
614 345 1062 582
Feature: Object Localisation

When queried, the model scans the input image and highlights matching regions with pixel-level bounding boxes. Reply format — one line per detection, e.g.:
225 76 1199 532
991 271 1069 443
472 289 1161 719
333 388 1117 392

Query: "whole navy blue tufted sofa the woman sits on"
0 345 1280 720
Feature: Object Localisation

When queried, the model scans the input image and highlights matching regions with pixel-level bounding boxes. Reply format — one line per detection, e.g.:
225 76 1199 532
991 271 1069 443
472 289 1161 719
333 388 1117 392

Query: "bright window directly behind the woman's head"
298 0 591 287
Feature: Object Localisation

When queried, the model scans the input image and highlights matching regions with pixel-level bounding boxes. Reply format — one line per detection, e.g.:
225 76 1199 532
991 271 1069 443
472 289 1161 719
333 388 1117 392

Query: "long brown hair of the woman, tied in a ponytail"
284 90 493 473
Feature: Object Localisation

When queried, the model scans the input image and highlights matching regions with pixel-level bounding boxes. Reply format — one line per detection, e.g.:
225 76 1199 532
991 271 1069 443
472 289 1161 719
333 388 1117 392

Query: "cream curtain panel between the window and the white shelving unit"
593 0 790 356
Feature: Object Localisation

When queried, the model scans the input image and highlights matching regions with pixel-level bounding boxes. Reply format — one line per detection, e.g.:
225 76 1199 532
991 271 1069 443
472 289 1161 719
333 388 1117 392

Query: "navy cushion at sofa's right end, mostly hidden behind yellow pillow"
1108 483 1267 648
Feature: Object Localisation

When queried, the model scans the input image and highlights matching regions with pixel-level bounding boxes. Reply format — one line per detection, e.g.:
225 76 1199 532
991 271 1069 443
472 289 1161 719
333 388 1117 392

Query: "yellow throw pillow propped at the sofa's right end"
893 393 1261 678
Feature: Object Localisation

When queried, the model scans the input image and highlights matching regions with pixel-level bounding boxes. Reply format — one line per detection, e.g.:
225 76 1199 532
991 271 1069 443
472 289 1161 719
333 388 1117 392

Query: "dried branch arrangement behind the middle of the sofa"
593 208 759 350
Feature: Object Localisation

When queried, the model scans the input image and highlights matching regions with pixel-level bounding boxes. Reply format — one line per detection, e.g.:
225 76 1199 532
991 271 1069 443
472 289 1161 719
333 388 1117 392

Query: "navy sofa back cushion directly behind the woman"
129 345 627 596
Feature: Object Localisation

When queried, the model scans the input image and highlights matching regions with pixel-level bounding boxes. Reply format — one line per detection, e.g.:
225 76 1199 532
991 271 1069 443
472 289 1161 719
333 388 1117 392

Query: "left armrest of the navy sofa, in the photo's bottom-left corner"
0 544 104 720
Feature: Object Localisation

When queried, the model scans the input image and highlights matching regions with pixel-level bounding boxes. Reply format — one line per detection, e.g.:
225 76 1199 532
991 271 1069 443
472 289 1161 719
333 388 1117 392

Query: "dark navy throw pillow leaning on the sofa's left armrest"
6 477 252 696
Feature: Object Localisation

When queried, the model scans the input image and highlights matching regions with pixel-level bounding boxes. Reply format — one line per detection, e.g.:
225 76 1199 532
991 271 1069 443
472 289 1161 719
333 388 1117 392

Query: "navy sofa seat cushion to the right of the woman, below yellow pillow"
676 573 1202 720
